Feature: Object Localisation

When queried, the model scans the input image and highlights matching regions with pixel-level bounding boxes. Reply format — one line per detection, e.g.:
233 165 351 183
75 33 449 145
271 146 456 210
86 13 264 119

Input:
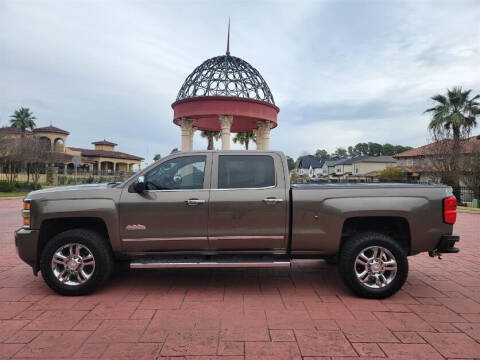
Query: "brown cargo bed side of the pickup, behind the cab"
291 183 451 254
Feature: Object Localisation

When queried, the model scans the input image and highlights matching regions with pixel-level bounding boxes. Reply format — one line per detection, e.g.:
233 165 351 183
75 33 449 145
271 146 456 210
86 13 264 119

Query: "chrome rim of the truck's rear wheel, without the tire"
354 246 397 289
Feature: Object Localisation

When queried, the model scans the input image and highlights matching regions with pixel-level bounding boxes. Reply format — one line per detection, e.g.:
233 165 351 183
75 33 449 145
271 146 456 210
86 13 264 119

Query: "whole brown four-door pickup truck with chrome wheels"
15 151 459 298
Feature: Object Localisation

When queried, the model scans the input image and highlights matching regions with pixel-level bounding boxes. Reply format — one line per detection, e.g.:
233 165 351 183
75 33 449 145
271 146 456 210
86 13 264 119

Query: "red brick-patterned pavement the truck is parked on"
0 200 480 360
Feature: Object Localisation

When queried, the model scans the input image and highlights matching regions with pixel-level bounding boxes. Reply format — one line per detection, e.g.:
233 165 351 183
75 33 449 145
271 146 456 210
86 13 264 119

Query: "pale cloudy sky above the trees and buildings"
0 0 480 165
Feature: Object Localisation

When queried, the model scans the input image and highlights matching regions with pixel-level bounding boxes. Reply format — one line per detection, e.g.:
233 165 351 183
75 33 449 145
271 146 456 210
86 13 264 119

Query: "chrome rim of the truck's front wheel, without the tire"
51 243 95 286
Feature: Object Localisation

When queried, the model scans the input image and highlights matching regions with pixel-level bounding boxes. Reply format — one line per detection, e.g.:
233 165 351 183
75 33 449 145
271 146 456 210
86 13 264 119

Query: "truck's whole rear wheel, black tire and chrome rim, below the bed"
338 232 408 299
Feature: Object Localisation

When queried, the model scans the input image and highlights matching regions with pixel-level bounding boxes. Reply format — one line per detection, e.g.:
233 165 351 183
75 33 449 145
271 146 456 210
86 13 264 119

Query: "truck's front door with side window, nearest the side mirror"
119 153 212 252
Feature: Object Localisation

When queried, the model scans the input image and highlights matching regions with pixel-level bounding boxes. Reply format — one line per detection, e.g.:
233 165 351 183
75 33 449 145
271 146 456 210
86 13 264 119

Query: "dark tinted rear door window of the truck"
218 155 275 189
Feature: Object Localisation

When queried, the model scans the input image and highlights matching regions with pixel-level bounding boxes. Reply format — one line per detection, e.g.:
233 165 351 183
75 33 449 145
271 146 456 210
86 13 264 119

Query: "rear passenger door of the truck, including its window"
208 153 288 252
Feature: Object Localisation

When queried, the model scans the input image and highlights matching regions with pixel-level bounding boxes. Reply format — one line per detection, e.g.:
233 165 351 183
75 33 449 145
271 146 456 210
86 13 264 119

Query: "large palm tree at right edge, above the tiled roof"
425 86 480 144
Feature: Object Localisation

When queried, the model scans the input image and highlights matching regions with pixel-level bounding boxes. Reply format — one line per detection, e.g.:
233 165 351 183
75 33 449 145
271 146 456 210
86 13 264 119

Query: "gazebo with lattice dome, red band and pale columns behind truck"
172 24 280 151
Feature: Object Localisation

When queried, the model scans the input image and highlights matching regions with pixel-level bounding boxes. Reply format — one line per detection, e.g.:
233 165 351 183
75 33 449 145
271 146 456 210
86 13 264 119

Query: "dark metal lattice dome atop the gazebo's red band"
177 55 275 105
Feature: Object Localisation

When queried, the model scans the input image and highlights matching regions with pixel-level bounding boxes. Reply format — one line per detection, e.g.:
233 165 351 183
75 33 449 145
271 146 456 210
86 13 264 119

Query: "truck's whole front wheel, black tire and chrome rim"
40 229 114 296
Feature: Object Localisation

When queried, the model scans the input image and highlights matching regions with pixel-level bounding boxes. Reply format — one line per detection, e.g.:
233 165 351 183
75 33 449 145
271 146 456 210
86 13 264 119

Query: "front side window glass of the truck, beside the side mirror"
145 155 206 190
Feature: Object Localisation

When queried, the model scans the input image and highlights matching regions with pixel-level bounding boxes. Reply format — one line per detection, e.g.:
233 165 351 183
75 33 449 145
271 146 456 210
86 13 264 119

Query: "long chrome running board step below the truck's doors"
130 260 290 269
